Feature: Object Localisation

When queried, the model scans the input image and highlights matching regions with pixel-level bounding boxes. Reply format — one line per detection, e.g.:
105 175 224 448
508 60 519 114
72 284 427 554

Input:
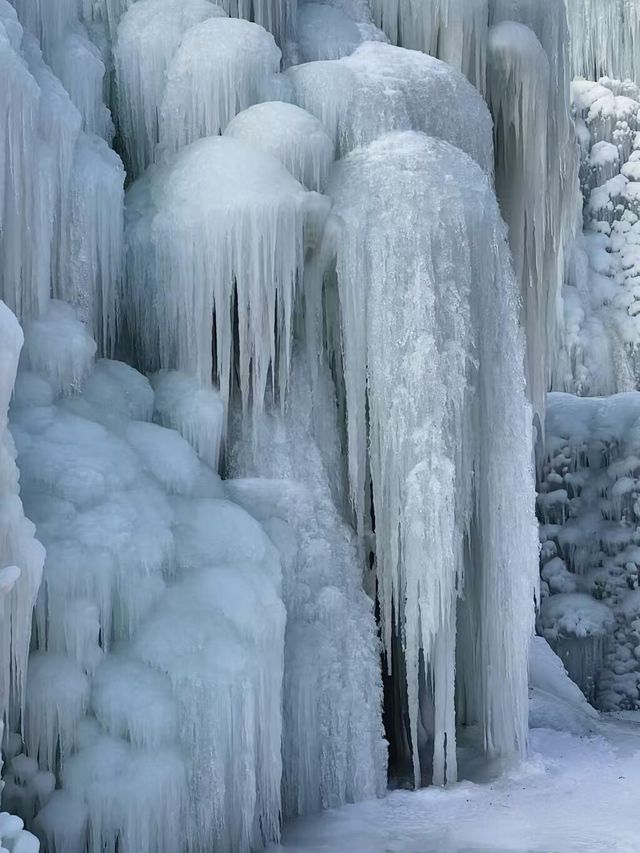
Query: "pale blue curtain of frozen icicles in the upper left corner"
0 2 124 350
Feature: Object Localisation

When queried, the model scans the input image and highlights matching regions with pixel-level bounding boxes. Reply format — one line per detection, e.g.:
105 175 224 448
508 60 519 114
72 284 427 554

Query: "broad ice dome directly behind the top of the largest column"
286 42 493 173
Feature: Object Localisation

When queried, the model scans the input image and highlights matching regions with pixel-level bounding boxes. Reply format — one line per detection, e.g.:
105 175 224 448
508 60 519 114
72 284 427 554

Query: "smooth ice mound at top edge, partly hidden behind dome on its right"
114 0 226 178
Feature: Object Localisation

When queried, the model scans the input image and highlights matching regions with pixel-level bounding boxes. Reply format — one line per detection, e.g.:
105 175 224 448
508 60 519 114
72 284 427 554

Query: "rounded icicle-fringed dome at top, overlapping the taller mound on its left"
159 17 281 152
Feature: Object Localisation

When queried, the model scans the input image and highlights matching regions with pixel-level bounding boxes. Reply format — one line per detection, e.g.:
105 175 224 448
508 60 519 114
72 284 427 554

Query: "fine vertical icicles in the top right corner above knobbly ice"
567 0 640 82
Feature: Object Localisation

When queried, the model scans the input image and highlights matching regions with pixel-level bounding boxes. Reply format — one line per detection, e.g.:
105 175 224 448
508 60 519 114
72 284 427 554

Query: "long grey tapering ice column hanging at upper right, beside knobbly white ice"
487 0 580 414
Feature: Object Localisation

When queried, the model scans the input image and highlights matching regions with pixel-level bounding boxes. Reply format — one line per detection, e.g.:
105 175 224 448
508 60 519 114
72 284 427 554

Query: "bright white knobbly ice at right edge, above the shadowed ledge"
556 78 640 395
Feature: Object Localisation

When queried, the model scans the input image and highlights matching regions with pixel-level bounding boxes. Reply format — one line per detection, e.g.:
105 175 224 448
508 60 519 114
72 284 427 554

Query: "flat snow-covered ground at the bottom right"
272 712 640 853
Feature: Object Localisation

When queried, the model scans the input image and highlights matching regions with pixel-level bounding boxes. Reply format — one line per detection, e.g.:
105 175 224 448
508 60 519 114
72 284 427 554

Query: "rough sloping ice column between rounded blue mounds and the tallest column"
227 346 386 816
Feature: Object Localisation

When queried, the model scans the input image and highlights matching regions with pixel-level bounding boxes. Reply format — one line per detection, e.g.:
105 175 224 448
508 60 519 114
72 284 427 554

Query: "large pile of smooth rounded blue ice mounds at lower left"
9 306 285 853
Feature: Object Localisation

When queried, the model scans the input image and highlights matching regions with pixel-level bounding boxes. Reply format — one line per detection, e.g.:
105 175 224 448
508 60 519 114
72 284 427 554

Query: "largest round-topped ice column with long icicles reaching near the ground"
326 132 538 784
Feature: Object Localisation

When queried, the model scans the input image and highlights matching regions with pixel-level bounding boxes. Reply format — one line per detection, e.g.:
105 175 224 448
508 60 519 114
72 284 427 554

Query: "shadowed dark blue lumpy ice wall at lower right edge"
538 391 640 710
